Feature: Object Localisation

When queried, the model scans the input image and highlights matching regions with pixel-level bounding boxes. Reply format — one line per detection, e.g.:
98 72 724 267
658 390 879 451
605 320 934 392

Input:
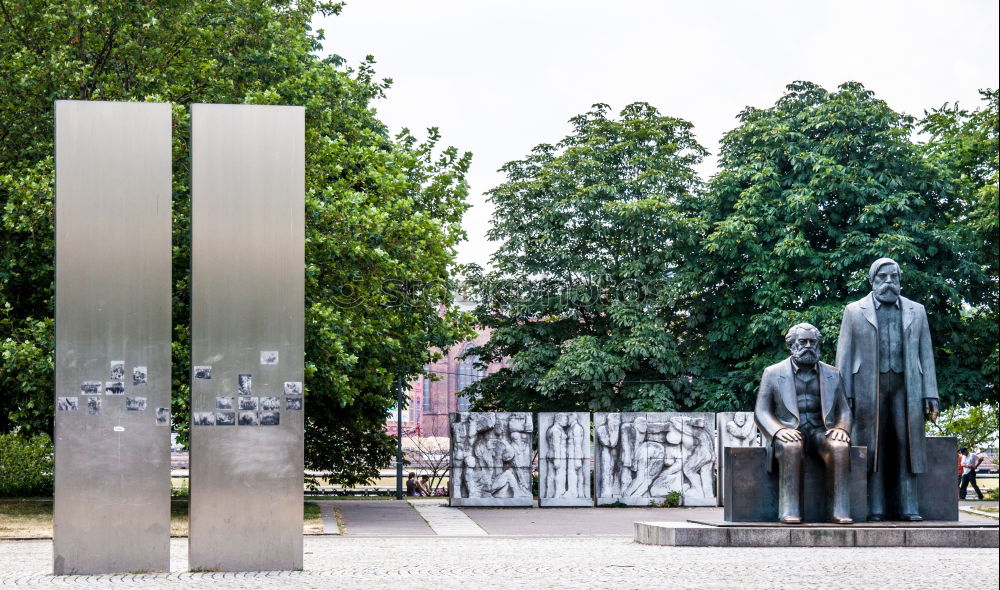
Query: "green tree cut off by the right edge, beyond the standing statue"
921 90 1000 408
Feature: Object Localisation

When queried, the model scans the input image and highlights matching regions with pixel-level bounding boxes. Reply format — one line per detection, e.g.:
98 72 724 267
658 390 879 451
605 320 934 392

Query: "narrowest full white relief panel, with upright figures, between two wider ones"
538 412 594 507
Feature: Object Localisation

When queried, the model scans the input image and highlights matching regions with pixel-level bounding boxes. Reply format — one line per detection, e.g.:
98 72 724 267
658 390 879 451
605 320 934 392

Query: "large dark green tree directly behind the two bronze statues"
685 82 989 409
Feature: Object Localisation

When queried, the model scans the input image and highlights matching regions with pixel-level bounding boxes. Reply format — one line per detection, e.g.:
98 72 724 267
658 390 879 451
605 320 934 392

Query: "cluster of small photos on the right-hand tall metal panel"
191 350 302 426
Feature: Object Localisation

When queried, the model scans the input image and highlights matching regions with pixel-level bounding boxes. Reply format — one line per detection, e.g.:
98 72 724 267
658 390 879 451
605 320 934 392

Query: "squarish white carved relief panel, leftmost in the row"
449 412 533 506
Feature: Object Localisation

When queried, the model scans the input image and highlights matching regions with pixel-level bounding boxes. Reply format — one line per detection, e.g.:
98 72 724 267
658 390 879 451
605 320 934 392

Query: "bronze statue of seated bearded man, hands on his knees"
754 323 854 524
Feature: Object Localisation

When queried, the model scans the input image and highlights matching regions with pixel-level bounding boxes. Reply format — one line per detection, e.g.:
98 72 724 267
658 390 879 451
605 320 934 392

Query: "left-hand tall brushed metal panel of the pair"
53 101 171 574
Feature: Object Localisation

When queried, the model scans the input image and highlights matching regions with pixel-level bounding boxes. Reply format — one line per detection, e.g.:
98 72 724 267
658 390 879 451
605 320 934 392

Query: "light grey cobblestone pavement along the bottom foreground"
0 536 1000 590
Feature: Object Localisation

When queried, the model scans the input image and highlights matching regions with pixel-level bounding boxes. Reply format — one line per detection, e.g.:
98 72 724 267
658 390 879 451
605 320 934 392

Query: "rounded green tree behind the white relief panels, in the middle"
466 103 705 411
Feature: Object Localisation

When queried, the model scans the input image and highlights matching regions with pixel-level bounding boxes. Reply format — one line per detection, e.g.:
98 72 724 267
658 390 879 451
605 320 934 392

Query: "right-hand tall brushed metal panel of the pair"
189 104 305 571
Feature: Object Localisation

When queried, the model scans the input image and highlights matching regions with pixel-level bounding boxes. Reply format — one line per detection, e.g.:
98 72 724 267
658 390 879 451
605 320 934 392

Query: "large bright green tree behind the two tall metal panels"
0 0 470 484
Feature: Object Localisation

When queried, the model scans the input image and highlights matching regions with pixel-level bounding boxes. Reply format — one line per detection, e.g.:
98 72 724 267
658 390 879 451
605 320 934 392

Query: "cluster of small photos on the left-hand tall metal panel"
56 361 170 426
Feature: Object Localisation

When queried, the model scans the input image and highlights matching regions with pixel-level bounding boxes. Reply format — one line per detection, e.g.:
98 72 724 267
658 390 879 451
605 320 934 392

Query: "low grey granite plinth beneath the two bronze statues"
634 521 1000 548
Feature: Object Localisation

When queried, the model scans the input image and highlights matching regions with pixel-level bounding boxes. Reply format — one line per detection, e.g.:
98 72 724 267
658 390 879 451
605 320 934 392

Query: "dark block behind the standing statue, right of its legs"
916 436 958 520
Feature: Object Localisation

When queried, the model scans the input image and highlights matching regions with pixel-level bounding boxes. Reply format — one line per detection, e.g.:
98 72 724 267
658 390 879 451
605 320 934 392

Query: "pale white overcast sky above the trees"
313 0 1000 264
